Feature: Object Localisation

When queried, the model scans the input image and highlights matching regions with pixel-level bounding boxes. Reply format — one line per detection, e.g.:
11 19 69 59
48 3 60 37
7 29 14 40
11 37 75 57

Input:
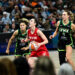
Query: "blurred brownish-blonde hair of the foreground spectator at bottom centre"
33 56 55 75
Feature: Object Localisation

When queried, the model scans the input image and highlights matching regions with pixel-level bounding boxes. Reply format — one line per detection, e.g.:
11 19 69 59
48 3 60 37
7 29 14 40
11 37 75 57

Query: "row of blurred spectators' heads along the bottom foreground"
0 56 75 75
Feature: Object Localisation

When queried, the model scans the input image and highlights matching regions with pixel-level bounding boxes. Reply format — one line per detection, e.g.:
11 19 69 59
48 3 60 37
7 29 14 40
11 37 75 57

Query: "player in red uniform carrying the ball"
27 18 49 67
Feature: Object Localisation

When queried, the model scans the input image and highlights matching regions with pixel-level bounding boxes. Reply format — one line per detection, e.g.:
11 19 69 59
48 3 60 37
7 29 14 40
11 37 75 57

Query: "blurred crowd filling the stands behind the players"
0 0 75 33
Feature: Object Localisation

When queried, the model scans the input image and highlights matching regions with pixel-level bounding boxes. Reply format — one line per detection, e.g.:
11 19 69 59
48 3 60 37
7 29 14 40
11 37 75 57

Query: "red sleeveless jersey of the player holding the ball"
28 28 47 51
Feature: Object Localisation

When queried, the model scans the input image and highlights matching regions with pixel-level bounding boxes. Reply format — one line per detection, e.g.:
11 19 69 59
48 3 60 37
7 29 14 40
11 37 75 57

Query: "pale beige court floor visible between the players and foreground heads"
0 50 75 73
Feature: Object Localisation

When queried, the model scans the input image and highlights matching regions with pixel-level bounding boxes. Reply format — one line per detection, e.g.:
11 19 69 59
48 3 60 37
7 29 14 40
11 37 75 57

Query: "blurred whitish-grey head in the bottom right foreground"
58 63 74 75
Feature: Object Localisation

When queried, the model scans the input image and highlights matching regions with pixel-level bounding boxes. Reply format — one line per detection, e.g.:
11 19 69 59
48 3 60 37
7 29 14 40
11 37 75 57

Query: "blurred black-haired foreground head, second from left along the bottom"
14 57 30 75
